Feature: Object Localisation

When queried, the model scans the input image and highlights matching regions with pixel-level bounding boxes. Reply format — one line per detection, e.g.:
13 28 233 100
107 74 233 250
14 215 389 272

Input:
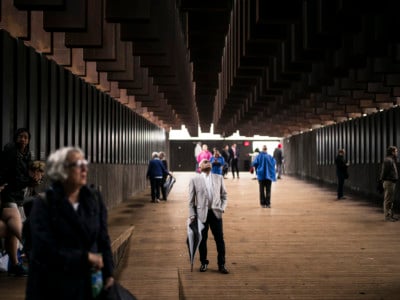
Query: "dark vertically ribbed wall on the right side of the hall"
284 107 400 202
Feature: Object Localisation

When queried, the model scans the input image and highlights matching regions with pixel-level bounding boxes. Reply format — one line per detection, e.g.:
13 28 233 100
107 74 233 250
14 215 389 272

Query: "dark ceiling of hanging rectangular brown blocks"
0 0 400 136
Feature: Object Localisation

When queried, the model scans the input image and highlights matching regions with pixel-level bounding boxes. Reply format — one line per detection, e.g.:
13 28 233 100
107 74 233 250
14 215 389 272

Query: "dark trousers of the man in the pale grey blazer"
199 209 225 266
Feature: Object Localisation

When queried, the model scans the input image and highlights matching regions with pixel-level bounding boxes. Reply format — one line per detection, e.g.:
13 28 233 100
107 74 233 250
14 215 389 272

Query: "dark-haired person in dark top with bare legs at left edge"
0 128 39 276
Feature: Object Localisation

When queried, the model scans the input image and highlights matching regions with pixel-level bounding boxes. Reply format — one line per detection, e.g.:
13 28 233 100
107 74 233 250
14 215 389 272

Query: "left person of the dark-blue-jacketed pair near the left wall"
146 152 172 203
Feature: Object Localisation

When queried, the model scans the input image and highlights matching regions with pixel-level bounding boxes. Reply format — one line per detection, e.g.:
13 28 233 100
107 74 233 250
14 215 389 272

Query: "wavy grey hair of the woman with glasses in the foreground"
46 147 85 182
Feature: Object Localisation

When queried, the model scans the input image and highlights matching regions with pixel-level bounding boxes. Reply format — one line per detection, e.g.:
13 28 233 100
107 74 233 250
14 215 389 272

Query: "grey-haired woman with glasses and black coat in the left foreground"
26 147 114 300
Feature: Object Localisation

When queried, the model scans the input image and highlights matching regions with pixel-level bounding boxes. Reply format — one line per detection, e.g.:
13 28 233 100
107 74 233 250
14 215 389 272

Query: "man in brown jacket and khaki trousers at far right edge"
380 146 399 222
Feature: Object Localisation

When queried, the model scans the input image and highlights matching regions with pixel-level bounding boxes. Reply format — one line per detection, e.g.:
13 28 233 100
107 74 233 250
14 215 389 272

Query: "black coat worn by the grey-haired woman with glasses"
26 184 114 300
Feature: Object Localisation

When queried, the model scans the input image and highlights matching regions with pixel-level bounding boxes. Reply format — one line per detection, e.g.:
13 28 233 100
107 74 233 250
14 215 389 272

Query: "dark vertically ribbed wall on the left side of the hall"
0 30 169 206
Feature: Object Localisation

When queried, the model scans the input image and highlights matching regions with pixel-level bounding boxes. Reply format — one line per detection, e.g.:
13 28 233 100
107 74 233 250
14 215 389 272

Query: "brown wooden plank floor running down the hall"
0 172 400 300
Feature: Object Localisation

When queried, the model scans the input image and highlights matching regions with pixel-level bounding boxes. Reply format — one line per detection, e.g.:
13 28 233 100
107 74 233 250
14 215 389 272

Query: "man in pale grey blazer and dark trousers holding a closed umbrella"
189 159 229 274
